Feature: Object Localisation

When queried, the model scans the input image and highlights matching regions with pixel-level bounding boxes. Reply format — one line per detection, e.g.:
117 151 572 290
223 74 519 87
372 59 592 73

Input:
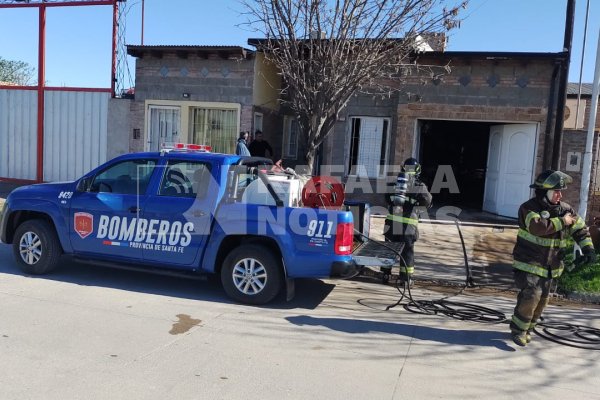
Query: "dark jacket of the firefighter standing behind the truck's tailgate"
385 175 431 240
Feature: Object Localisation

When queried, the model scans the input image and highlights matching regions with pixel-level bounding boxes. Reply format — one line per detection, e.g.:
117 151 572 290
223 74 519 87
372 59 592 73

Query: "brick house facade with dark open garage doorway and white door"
324 52 571 217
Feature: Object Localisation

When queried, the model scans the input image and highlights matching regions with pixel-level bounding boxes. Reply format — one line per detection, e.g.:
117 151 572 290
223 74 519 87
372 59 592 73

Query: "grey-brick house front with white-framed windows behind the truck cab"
127 46 280 153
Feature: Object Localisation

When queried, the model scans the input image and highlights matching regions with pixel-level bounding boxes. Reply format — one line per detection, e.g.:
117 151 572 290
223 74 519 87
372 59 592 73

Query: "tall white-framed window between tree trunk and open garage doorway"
348 117 389 178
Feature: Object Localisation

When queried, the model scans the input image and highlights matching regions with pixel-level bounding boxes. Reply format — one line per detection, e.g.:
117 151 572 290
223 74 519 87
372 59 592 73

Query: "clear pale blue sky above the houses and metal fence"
0 0 600 88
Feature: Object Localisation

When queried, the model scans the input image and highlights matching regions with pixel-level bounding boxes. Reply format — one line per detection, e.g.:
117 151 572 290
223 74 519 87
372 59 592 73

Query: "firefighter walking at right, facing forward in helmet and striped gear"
510 170 596 346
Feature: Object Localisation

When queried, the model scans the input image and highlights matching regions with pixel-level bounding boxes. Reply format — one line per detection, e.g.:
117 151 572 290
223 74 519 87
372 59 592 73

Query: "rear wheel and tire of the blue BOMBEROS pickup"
221 245 283 304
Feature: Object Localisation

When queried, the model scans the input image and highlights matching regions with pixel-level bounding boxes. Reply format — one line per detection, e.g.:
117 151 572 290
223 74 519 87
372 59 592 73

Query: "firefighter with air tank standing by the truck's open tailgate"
381 157 431 284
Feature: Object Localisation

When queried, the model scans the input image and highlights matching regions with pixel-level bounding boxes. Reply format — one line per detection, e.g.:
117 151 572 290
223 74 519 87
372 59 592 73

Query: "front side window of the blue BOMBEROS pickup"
90 160 156 194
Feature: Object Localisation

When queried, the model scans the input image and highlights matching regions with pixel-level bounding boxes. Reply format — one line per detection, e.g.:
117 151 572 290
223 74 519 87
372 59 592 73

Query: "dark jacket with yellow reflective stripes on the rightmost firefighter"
513 195 593 278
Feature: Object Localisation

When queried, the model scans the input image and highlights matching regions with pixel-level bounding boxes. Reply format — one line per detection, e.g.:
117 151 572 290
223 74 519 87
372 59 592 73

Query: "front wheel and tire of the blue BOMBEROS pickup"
13 219 62 275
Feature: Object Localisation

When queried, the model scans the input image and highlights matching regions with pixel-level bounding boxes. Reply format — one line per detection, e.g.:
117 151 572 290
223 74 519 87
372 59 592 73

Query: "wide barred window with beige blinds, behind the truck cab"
190 107 239 154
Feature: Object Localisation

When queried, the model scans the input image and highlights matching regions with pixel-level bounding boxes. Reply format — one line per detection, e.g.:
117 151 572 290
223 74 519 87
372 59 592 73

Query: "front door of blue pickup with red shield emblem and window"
69 159 157 261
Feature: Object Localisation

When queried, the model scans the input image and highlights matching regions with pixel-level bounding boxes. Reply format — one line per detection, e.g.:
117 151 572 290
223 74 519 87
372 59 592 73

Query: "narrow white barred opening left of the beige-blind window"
146 106 181 151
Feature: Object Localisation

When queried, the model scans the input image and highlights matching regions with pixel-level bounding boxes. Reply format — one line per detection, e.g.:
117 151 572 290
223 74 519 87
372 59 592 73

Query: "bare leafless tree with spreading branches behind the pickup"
241 0 467 171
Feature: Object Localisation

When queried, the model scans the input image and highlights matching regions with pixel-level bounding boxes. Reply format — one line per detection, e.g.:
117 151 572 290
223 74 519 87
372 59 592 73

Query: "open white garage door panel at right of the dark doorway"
483 124 537 218
